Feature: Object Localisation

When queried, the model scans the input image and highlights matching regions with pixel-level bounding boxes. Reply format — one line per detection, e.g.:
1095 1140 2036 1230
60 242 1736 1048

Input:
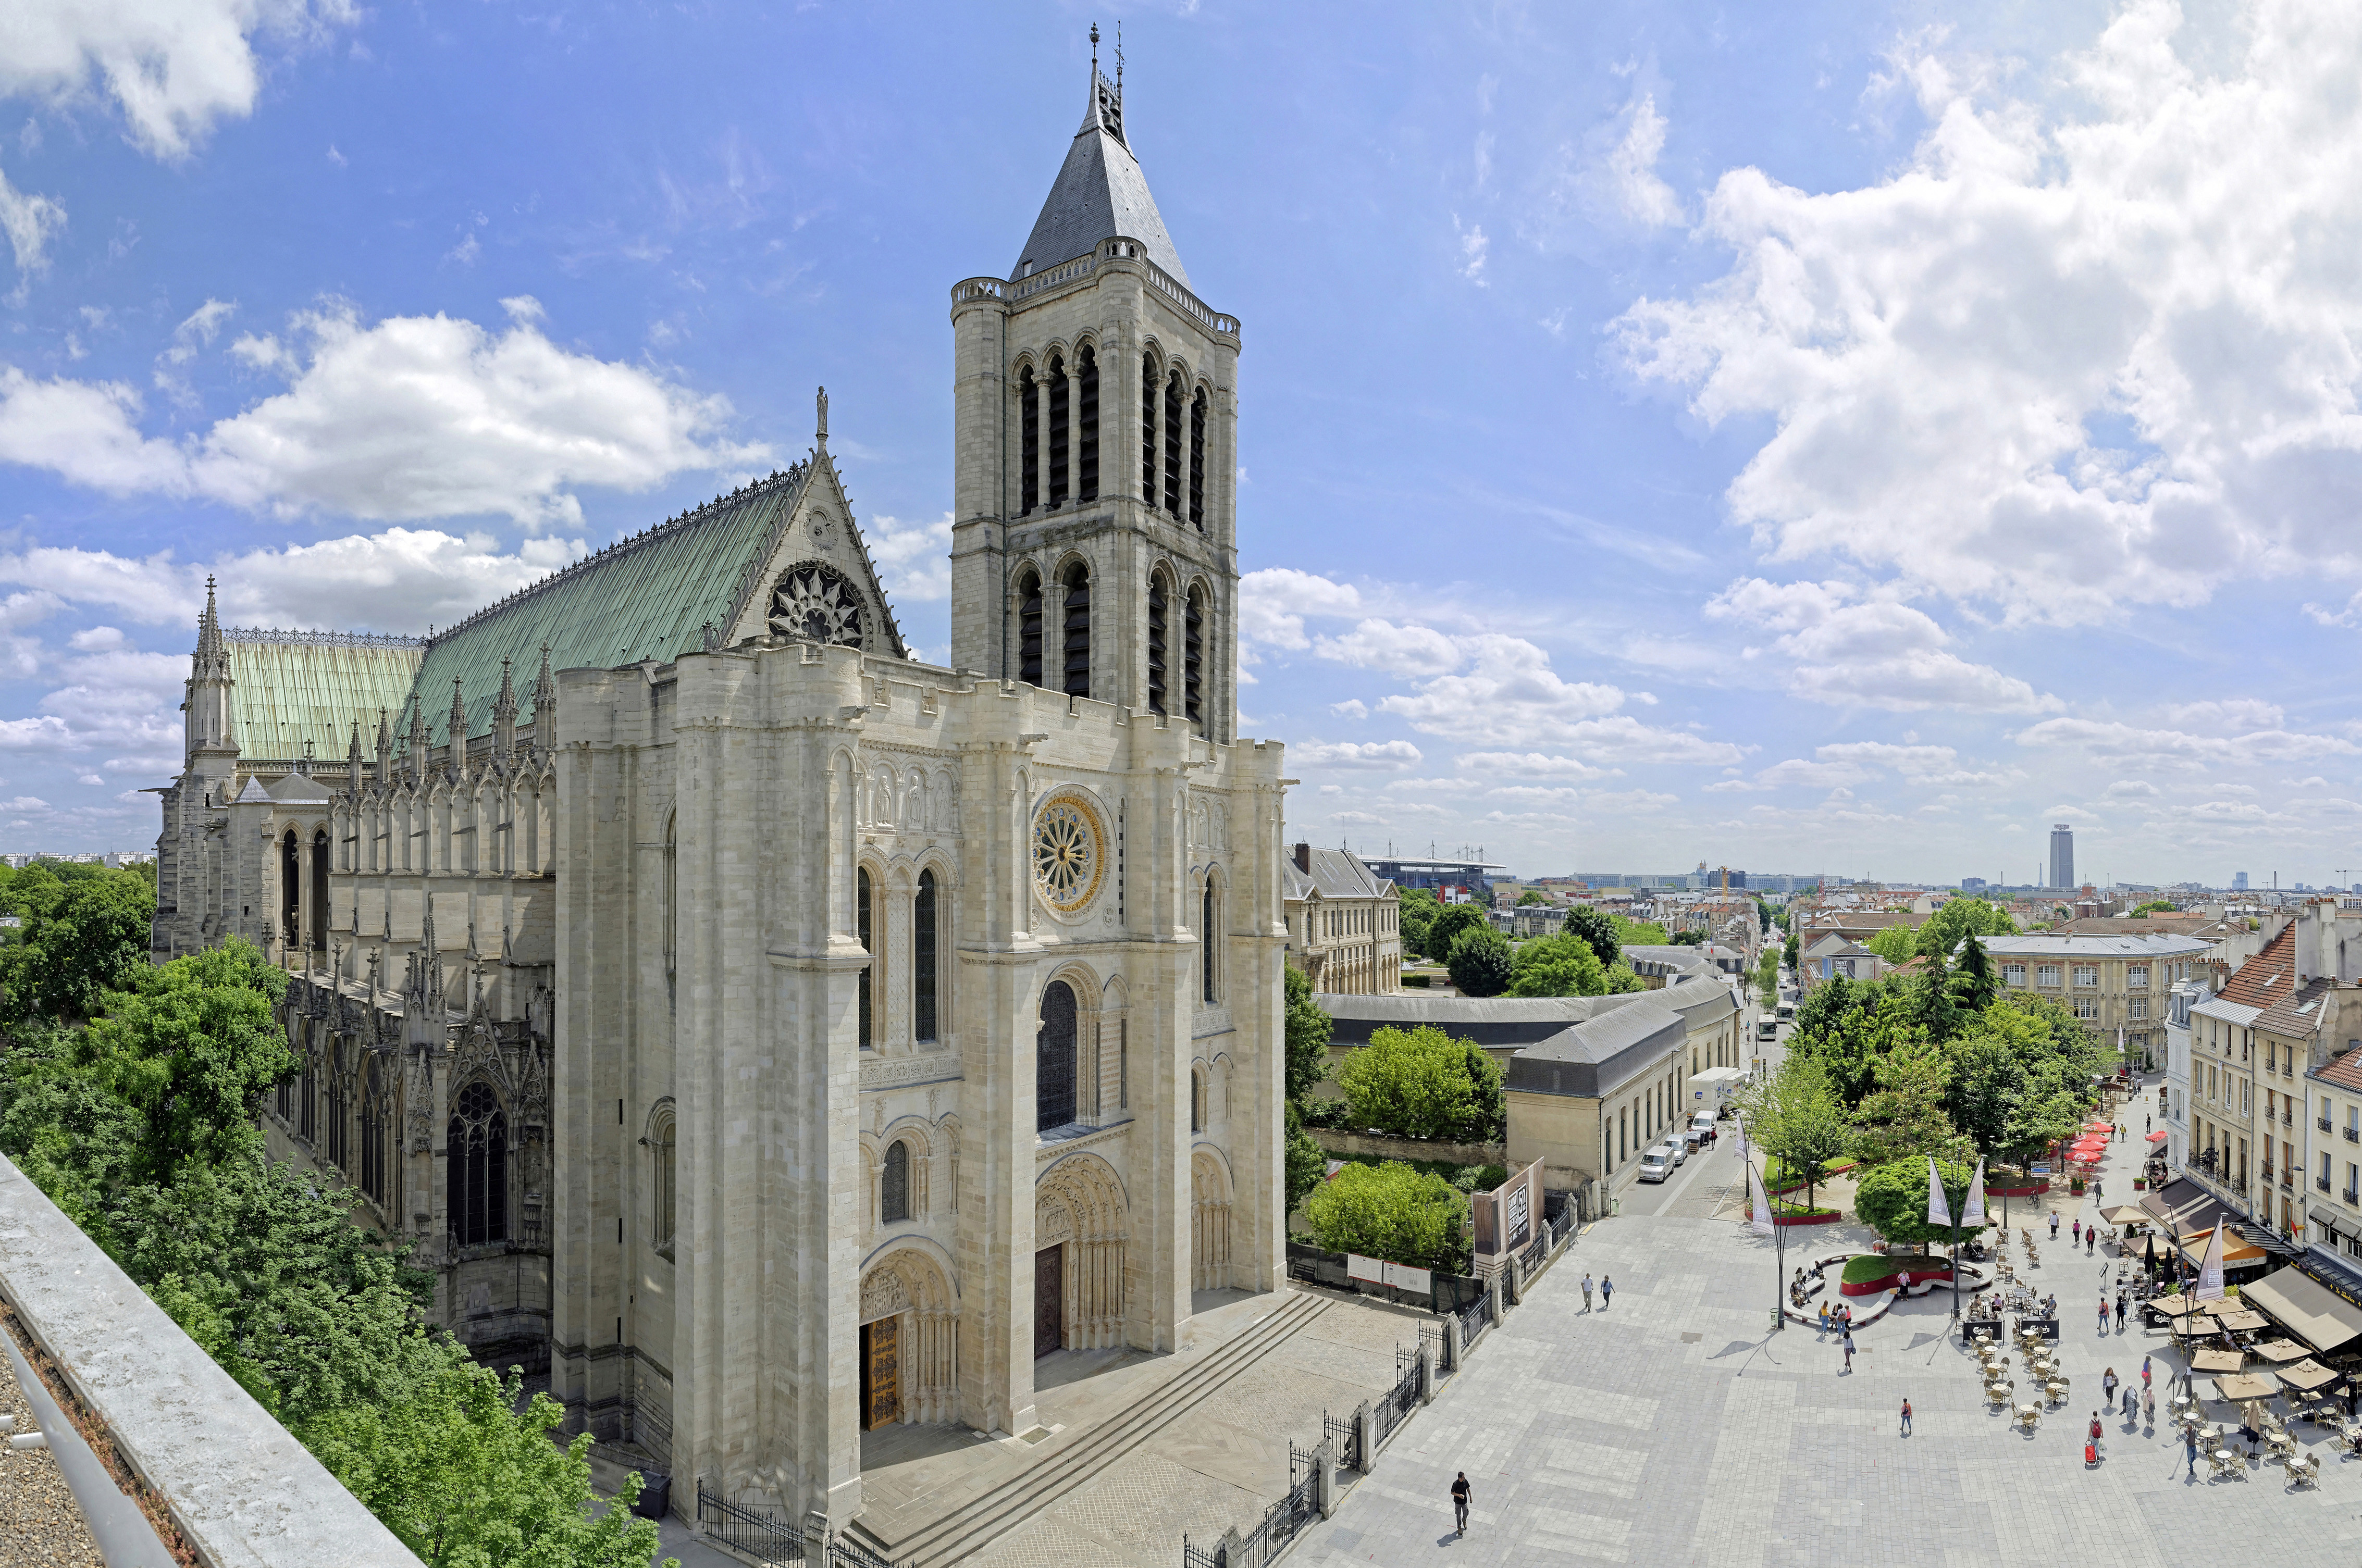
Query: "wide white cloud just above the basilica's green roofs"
0 297 770 529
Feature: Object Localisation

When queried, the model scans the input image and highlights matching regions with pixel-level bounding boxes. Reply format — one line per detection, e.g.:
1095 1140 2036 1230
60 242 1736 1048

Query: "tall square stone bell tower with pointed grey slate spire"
952 26 1238 741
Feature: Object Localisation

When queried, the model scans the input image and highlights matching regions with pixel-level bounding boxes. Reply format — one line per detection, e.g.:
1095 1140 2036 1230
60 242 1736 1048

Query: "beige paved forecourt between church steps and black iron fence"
969 1297 1431 1568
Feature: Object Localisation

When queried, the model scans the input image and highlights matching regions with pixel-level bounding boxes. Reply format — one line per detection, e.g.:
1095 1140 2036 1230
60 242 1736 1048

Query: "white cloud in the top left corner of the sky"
0 0 359 158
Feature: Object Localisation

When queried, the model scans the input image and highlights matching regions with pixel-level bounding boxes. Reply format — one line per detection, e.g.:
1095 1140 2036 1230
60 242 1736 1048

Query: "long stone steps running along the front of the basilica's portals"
850 1292 1332 1568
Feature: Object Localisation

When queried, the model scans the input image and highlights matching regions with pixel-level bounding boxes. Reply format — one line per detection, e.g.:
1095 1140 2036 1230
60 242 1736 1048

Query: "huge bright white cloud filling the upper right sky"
1611 0 2362 623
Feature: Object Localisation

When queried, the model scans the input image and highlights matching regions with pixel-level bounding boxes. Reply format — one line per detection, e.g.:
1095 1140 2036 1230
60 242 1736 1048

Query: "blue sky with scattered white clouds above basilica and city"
0 0 2362 883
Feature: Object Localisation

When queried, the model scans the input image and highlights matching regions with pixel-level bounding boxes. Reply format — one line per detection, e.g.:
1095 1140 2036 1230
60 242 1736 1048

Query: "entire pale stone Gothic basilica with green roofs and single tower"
154 52 1287 1525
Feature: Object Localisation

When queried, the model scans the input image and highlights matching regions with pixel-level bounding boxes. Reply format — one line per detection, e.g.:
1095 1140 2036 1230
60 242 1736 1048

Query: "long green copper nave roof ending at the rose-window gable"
394 463 812 744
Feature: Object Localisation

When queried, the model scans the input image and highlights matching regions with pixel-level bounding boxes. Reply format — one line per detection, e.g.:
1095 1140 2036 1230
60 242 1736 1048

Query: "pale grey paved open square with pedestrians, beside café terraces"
1292 1072 2362 1568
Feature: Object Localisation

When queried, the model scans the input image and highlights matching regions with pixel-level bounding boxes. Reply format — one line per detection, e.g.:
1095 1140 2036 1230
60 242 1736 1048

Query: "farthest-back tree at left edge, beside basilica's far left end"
0 862 156 1027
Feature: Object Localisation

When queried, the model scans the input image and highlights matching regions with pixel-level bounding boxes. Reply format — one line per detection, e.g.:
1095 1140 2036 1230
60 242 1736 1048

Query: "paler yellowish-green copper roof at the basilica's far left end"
222 628 425 761
